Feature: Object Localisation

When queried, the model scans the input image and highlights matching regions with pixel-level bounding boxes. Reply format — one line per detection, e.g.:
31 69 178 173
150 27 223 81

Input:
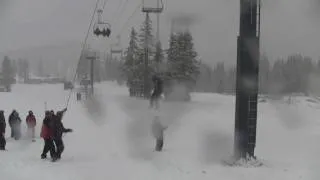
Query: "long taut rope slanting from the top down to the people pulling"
65 0 100 108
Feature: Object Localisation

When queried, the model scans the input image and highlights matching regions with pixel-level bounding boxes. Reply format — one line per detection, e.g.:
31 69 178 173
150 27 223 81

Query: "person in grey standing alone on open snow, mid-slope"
152 115 168 151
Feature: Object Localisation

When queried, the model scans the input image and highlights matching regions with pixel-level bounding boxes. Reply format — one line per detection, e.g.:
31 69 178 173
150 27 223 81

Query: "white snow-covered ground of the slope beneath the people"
0 83 320 180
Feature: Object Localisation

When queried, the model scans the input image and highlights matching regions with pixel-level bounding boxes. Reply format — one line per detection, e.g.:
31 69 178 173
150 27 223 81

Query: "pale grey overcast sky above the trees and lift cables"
0 0 320 63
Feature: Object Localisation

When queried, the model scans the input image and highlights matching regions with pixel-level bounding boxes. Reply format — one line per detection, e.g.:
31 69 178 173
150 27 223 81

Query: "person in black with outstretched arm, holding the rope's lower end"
53 108 72 160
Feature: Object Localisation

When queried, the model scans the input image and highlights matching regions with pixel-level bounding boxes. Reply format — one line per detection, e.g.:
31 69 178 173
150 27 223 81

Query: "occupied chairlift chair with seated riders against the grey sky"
93 9 111 37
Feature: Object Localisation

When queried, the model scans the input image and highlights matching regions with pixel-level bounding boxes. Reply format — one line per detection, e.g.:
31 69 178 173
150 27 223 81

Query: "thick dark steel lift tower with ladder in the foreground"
234 0 260 160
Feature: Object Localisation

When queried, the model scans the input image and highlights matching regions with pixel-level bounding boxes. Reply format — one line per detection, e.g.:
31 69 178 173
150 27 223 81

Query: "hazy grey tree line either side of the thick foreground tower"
196 54 320 95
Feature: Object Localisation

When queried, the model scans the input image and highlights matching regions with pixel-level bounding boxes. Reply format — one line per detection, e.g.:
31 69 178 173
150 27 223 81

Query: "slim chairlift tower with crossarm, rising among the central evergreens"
142 0 163 98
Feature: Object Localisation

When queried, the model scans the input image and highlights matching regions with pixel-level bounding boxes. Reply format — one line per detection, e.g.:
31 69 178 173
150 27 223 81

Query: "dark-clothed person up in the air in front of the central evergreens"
150 75 163 108
